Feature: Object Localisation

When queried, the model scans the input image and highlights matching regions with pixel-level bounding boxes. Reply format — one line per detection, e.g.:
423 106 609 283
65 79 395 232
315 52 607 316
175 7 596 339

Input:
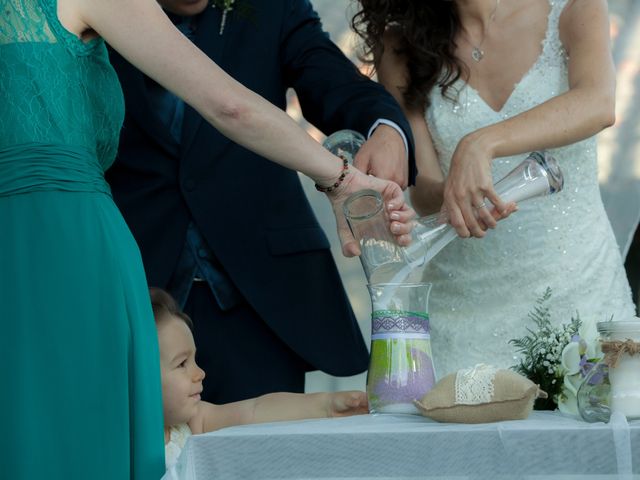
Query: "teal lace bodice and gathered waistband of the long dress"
0 0 124 194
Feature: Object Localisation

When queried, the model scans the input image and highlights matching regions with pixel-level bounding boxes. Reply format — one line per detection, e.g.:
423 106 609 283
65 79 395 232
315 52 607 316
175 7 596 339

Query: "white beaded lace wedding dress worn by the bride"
423 0 634 377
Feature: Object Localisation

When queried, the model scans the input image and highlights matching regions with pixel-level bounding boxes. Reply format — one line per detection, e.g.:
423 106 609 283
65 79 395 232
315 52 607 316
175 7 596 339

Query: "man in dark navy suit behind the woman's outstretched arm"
107 0 415 403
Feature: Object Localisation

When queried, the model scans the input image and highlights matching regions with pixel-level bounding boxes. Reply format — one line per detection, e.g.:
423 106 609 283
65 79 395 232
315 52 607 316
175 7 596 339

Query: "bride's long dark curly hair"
351 0 467 108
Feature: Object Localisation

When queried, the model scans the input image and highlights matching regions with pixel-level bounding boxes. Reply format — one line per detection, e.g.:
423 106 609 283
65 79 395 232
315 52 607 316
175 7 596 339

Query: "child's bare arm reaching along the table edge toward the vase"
189 391 369 434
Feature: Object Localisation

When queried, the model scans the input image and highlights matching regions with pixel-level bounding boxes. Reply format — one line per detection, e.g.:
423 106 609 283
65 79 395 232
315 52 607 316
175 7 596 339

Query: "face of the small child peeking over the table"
158 315 204 426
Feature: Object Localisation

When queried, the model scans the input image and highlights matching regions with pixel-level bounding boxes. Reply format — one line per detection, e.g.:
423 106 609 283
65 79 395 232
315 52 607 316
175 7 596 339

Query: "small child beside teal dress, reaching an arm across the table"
150 288 369 469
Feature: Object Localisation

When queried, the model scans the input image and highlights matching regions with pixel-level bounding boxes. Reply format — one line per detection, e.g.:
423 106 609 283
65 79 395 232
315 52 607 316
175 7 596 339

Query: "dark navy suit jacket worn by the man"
107 0 415 375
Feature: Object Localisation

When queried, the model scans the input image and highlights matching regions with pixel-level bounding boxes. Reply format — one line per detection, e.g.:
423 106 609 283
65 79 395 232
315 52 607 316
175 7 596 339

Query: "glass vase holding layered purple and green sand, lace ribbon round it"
367 283 435 414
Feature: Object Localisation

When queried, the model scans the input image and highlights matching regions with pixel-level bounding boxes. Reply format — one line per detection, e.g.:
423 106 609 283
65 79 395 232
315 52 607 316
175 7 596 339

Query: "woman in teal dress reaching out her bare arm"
0 0 412 480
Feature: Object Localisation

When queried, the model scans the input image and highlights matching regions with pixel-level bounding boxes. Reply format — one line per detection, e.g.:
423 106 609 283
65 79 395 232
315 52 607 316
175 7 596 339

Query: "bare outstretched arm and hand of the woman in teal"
58 0 413 255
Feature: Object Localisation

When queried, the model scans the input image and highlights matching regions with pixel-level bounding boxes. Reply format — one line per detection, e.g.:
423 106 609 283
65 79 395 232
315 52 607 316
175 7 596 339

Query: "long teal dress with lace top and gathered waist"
0 0 164 480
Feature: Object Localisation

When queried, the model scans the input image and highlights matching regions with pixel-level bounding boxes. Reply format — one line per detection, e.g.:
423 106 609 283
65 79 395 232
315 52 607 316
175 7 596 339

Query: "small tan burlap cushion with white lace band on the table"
414 365 547 423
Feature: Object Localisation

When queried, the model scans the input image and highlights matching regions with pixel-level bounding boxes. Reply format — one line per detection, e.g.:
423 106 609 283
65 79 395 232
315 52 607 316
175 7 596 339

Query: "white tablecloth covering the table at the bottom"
164 412 640 480
